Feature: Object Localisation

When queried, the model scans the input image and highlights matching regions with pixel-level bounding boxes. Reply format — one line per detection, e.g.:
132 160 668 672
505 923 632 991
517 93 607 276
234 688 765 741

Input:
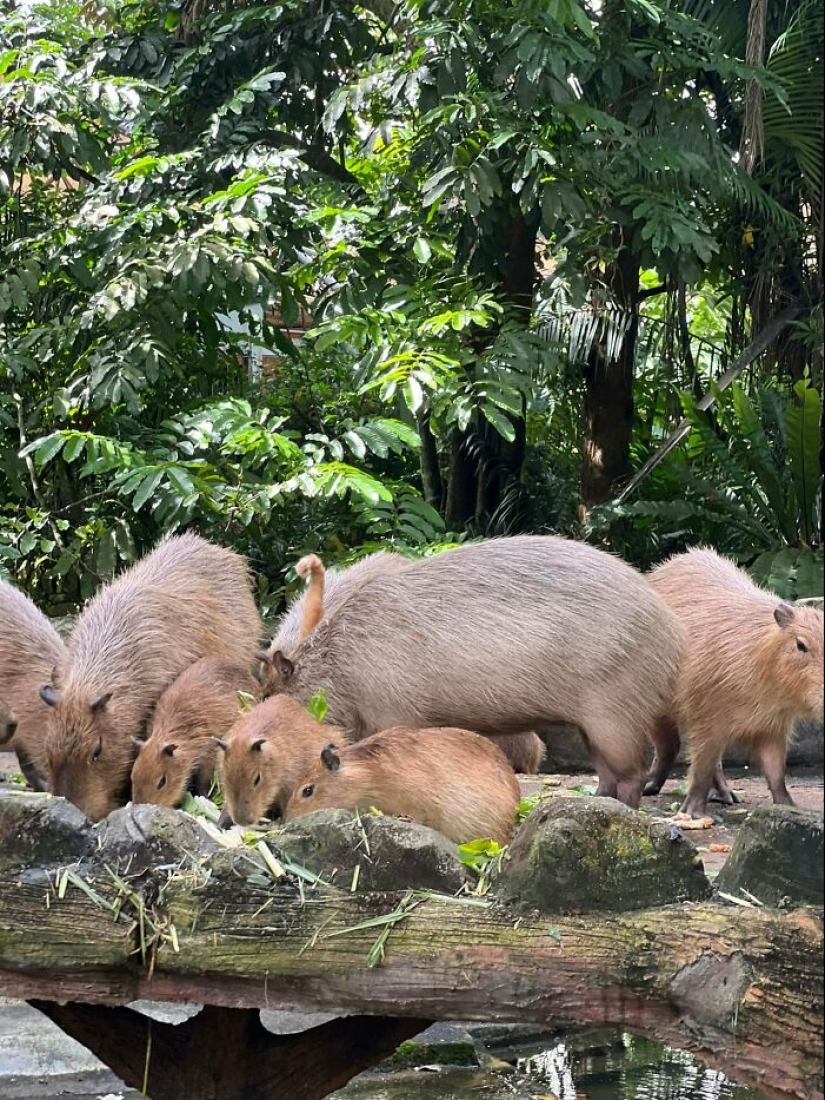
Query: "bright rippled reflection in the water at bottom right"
517 1035 763 1100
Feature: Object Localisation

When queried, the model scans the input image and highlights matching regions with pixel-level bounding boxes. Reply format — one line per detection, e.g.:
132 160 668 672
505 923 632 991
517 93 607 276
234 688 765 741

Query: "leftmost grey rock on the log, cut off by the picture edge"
0 788 95 867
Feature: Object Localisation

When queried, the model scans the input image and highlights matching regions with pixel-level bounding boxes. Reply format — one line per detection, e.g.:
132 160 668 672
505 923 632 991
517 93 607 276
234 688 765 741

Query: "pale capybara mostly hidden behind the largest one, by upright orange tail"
260 550 413 668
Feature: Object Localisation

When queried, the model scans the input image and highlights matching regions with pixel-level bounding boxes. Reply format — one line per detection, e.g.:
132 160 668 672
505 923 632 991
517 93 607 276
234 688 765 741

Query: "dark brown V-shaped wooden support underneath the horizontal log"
30 1000 429 1100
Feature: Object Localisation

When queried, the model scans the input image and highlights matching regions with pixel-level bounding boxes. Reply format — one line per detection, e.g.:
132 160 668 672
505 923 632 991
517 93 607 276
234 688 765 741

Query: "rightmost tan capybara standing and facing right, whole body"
645 549 825 815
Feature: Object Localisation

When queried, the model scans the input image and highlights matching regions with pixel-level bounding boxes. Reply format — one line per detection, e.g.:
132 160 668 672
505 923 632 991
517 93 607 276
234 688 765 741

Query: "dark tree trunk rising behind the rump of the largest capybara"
581 249 639 518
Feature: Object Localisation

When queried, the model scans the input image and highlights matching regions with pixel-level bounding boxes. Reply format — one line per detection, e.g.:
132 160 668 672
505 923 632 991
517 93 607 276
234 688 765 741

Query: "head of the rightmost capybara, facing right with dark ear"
763 603 825 721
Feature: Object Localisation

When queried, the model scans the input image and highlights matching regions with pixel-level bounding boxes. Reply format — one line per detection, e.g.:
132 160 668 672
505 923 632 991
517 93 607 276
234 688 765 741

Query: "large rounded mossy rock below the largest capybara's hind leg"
494 798 711 913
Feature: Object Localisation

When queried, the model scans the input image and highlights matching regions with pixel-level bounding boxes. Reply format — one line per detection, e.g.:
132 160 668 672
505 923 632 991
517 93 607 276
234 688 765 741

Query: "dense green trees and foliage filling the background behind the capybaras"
0 0 823 607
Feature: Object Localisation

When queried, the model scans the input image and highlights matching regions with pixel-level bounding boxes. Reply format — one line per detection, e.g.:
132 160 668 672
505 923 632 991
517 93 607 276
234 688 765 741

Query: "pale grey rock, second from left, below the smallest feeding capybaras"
97 803 222 872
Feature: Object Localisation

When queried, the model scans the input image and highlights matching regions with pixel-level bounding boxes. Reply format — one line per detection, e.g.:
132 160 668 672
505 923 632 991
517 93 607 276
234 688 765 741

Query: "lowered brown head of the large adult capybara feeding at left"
40 683 133 822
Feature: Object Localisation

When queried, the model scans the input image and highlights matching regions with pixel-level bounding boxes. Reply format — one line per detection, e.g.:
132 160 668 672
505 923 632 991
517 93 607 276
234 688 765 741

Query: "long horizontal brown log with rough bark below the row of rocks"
0 864 824 1100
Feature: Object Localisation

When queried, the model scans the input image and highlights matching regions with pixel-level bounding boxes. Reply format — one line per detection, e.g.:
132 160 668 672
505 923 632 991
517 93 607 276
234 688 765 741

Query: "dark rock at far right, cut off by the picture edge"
716 806 825 906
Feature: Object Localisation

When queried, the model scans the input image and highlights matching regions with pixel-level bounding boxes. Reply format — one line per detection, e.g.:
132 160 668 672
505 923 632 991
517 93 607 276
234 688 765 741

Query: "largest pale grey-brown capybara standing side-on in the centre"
258 536 682 806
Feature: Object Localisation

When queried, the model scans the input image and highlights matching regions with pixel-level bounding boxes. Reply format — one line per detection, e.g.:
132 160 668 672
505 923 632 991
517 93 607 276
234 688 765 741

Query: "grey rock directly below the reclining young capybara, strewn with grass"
275 810 468 893
